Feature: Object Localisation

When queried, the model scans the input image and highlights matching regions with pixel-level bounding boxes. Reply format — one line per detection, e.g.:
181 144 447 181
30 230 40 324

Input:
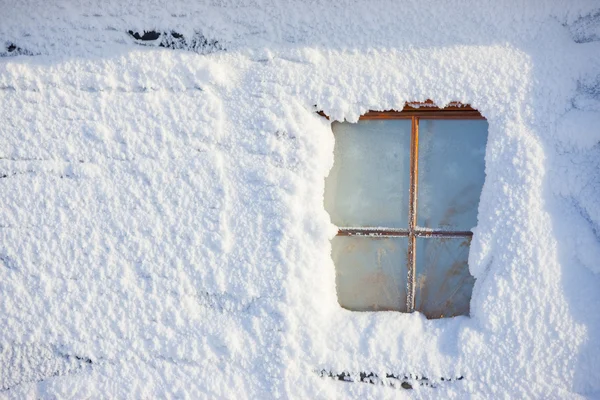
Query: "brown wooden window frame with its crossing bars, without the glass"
319 100 485 313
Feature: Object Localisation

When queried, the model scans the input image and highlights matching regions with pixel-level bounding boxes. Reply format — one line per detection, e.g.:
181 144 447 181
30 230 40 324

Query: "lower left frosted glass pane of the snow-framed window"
331 236 408 311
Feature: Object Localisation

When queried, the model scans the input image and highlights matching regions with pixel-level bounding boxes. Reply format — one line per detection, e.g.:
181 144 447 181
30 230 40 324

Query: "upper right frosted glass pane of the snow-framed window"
417 120 488 230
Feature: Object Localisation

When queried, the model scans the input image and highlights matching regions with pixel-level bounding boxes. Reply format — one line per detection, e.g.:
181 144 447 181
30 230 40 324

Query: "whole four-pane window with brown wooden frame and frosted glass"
325 102 488 318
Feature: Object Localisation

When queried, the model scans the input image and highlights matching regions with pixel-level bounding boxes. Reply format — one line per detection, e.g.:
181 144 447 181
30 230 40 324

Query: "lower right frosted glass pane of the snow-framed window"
415 238 475 318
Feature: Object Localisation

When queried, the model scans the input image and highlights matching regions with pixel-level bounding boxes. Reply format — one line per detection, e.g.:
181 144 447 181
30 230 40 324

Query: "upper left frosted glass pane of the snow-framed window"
325 120 410 228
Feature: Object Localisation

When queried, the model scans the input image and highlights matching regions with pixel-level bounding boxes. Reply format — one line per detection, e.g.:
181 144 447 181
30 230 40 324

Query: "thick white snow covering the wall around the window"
0 0 600 398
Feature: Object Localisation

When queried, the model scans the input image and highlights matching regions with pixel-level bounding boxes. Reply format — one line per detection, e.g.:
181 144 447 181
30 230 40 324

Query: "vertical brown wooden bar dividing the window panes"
406 116 419 313
